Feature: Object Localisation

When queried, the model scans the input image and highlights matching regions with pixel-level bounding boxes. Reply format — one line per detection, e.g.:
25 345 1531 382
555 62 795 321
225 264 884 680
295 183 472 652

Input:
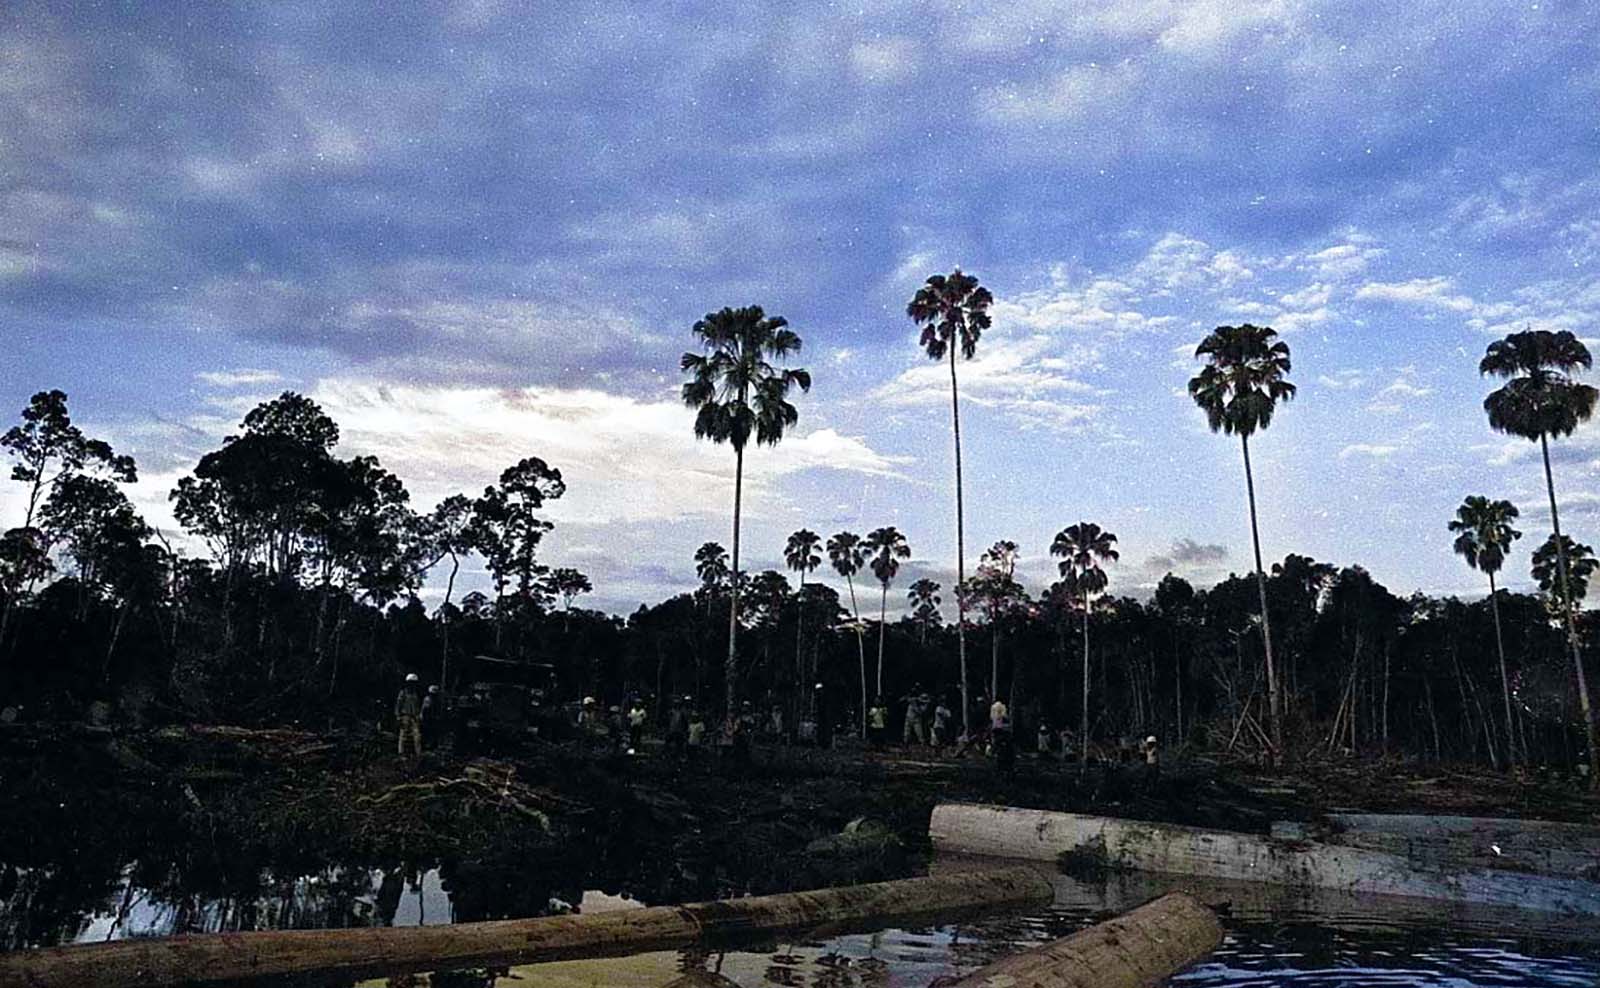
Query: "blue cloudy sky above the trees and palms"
0 0 1600 612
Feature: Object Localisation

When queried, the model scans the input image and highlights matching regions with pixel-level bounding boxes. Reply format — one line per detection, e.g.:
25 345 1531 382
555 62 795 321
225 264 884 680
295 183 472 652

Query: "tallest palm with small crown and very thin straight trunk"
906 267 994 735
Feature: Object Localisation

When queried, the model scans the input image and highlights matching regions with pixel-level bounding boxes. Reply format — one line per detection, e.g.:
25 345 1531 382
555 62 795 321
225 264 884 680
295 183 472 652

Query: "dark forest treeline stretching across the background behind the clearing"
0 385 1595 766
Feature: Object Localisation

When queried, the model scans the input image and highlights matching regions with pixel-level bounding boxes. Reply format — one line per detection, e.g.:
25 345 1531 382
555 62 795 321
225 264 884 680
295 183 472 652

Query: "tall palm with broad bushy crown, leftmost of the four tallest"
682 305 811 716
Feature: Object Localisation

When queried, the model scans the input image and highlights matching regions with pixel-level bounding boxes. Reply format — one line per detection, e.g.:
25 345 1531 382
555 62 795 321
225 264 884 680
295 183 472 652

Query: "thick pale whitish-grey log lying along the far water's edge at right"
928 804 1600 916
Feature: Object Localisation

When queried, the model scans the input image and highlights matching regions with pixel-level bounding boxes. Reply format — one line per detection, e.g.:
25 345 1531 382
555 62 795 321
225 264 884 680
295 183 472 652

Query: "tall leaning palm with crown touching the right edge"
1478 329 1600 788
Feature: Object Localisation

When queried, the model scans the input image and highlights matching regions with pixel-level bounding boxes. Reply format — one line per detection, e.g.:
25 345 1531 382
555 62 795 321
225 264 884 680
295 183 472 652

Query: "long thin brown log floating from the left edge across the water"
0 868 1053 988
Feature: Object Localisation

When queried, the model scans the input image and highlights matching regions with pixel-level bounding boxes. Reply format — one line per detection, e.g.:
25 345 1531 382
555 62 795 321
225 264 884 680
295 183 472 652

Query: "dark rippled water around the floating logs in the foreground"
0 860 1600 988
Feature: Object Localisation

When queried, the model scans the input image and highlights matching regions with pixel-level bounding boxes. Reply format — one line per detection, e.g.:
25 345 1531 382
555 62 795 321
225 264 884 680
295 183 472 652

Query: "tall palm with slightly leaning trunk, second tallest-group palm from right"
1189 323 1294 763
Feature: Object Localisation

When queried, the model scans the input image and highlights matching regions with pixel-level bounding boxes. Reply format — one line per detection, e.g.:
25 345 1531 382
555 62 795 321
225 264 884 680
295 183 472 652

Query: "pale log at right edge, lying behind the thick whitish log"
1272 814 1600 878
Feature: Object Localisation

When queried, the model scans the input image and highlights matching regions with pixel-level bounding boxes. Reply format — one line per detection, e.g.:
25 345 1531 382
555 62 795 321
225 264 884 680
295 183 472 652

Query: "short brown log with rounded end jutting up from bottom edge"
950 892 1222 988
